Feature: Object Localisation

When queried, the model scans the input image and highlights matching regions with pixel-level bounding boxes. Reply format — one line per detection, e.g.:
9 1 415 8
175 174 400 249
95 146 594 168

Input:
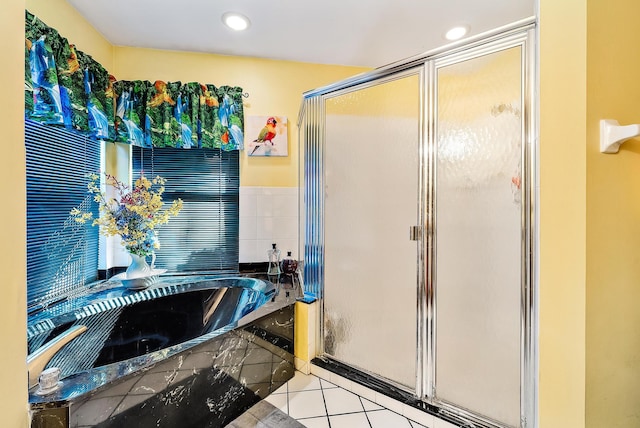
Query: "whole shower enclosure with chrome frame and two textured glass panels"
299 21 536 427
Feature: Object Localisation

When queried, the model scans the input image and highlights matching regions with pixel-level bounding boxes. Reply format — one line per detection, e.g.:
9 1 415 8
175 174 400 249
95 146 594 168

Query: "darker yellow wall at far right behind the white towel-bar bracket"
586 0 640 428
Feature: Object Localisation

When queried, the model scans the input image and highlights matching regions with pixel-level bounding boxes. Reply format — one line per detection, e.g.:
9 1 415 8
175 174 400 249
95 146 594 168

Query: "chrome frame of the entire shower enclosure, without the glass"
298 18 538 428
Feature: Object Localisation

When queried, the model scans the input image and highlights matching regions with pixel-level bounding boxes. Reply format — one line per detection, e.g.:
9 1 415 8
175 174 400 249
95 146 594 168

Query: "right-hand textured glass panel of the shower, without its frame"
435 47 522 426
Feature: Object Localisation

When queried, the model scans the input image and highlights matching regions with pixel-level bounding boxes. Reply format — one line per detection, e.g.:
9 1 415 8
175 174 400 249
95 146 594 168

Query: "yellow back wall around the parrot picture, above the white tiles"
113 47 368 187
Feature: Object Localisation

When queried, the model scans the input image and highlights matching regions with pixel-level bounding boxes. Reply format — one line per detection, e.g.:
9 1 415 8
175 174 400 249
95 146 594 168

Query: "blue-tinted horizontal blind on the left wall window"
25 120 100 312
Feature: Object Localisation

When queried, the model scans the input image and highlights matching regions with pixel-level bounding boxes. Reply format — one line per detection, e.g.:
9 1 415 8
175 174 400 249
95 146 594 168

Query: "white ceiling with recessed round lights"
67 0 535 67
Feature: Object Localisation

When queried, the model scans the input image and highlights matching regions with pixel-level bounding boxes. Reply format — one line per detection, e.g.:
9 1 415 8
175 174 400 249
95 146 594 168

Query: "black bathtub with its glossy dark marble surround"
27 275 295 428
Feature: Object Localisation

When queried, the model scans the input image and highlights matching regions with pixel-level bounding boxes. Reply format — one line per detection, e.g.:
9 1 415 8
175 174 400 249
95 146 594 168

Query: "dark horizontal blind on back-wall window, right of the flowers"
131 146 240 273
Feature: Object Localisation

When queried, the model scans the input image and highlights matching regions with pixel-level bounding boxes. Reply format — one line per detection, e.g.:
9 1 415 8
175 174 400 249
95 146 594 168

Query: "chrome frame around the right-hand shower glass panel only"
423 26 538 428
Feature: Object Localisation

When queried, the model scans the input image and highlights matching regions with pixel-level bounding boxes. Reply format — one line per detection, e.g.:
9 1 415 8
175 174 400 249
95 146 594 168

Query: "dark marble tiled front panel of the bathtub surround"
70 326 293 428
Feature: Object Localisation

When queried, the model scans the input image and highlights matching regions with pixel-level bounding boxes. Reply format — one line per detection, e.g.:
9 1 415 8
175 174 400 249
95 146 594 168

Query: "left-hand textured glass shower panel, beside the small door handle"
324 75 420 390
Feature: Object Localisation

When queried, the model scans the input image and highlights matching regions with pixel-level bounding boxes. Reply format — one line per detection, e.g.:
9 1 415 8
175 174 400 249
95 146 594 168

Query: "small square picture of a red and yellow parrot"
244 115 289 156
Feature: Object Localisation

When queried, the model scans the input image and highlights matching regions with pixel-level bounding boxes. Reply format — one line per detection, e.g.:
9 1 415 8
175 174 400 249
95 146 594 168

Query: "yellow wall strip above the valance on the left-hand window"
23 0 113 74
